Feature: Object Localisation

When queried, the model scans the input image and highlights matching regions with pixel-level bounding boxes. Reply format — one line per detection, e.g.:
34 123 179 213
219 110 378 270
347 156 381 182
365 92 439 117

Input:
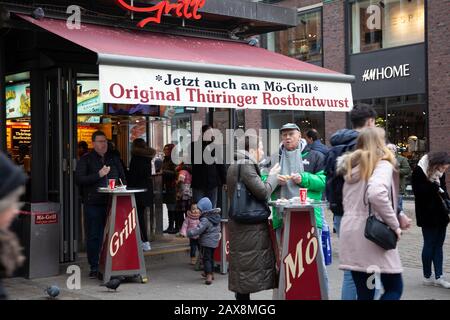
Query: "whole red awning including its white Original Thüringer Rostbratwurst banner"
20 15 354 112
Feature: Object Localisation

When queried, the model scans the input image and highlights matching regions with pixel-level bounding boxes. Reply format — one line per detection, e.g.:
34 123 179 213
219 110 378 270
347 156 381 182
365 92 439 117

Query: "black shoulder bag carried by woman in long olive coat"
228 164 271 224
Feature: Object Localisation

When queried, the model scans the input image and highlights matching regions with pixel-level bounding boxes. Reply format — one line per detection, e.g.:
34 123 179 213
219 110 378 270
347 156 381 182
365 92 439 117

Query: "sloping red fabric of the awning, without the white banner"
19 15 338 74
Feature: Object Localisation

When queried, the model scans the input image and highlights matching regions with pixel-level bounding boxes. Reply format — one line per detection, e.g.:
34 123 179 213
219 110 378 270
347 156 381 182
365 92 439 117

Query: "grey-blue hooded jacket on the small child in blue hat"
187 208 221 248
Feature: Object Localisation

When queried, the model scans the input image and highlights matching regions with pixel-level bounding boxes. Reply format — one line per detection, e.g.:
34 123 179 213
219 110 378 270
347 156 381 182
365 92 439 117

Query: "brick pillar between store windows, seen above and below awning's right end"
323 0 347 141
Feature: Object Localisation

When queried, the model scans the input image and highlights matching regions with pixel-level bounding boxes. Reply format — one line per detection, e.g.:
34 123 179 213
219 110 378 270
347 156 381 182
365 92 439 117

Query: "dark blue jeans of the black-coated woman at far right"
422 227 447 279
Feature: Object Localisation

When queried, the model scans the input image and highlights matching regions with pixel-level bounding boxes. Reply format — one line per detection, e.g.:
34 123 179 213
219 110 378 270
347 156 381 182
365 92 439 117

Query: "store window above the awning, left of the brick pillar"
267 8 322 66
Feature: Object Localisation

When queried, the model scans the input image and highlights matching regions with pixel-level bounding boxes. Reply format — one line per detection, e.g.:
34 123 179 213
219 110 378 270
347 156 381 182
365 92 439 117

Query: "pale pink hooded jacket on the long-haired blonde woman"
337 154 403 274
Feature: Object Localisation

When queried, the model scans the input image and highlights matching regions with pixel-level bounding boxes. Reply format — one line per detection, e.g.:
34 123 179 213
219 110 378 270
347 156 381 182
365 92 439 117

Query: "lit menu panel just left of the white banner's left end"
77 80 103 114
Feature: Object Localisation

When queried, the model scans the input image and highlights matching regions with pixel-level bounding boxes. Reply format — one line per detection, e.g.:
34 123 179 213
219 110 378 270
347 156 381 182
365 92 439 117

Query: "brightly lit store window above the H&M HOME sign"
350 0 425 53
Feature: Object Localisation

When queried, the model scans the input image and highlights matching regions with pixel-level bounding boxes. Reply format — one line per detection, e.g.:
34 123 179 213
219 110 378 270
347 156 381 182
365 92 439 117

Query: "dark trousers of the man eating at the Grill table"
84 205 108 271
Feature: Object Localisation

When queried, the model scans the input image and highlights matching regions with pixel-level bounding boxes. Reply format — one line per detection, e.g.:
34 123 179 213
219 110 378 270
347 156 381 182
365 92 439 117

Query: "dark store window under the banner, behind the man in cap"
265 110 325 153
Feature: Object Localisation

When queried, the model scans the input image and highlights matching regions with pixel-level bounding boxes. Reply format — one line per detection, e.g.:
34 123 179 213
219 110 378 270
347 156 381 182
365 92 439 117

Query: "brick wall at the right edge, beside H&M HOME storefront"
427 0 450 189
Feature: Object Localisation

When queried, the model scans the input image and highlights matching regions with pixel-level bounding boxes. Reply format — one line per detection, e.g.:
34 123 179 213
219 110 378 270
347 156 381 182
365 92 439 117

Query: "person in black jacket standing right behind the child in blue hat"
191 125 226 207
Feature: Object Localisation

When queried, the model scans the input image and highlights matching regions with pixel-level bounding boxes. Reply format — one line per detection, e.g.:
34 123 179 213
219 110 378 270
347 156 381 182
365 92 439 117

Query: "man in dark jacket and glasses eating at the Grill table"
75 131 126 278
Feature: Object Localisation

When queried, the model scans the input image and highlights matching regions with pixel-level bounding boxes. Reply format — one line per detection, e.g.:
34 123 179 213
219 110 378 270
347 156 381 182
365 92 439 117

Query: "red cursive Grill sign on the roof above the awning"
116 0 206 28
